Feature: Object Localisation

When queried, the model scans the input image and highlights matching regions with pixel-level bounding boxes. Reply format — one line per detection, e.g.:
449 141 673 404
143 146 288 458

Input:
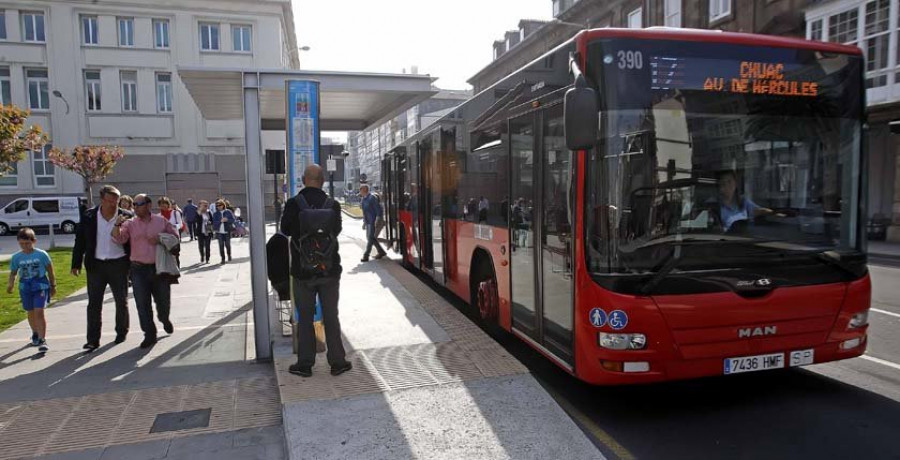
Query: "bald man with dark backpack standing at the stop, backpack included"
281 164 353 377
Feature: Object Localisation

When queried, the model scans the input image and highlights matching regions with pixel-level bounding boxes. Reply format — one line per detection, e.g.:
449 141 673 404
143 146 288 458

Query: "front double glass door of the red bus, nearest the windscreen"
509 104 574 364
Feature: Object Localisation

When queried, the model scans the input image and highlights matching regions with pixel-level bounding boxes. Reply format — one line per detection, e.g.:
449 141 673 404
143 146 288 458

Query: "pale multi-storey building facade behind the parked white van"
0 0 299 205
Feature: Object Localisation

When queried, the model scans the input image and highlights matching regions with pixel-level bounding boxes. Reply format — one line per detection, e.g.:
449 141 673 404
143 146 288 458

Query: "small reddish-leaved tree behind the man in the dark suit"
49 145 125 206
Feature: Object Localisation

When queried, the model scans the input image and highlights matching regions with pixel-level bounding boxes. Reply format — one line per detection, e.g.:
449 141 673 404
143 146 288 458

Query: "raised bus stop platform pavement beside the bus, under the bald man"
275 219 603 459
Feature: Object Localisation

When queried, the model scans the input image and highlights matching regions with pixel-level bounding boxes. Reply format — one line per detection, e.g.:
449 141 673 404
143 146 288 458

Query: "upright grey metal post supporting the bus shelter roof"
243 72 272 361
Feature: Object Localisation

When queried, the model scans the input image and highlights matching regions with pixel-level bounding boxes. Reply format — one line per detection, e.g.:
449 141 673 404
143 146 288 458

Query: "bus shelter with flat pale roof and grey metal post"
178 67 437 360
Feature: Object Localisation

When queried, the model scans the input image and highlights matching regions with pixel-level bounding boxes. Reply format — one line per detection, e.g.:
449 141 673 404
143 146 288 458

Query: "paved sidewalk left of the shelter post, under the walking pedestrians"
0 239 286 460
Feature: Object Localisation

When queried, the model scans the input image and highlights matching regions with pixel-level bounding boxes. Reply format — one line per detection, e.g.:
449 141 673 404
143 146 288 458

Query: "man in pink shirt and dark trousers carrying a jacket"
112 194 178 348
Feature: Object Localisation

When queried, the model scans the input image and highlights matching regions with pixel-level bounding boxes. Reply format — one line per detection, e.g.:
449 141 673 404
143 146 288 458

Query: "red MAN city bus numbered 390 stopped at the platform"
382 29 870 384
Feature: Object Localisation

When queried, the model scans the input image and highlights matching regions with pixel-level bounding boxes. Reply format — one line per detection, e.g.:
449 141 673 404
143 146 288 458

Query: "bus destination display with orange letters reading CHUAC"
650 56 819 97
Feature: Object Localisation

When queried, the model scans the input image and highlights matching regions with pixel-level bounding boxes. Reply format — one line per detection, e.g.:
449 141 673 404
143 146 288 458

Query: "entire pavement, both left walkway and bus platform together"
0 218 603 460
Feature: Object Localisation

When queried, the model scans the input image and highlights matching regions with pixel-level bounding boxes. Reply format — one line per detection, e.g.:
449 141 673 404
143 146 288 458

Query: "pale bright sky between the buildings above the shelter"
293 0 552 89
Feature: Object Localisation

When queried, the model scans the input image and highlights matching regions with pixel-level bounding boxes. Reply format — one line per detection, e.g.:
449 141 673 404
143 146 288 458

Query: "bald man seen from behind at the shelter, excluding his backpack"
281 164 352 377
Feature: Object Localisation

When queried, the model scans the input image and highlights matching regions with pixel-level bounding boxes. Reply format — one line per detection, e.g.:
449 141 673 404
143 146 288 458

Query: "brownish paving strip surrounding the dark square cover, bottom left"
0 377 281 459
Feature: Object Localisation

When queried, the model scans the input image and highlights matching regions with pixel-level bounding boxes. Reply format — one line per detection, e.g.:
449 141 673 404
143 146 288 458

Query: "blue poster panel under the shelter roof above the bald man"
285 80 319 196
